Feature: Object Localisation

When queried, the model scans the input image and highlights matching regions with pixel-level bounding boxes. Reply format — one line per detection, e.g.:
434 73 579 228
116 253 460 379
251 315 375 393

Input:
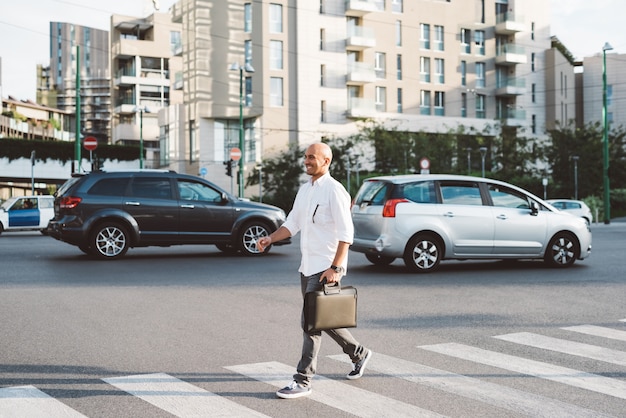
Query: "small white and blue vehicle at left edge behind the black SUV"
0 196 54 234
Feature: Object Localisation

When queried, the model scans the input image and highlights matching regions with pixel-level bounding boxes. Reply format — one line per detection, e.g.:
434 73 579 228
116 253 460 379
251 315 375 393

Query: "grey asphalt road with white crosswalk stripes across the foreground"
0 223 626 417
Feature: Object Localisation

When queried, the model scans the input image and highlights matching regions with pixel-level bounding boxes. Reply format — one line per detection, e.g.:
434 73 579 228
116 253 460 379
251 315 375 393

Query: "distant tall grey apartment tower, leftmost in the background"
37 22 111 142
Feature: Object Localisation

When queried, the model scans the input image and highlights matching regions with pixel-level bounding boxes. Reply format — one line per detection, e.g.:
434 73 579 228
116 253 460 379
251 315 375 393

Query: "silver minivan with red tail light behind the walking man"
350 174 591 272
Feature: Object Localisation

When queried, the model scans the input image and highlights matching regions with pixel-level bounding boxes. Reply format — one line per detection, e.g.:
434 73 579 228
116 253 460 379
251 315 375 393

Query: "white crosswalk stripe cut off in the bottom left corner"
0 385 85 418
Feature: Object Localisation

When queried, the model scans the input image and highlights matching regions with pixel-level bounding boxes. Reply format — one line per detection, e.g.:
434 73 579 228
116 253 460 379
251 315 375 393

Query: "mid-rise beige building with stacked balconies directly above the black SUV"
110 13 182 165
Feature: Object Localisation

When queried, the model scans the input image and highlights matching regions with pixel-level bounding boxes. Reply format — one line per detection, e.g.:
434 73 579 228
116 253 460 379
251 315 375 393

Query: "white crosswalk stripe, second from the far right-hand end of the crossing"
494 332 626 366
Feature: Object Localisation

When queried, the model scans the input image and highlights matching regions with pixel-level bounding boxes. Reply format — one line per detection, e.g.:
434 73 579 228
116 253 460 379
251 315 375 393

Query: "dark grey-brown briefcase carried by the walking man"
304 283 357 332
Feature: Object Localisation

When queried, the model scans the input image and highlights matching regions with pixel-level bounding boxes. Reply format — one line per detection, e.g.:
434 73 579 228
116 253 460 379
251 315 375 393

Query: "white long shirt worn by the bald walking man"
283 173 354 276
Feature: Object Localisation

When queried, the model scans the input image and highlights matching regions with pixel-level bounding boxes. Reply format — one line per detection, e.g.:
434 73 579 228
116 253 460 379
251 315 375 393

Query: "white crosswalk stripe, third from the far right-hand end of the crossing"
419 343 626 399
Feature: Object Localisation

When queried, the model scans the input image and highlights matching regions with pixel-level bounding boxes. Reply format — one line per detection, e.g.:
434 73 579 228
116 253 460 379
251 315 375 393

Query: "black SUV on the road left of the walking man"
47 170 290 260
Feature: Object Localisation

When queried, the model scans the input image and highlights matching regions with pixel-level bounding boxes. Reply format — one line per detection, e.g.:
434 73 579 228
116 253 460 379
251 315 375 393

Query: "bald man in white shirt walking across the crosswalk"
257 143 372 399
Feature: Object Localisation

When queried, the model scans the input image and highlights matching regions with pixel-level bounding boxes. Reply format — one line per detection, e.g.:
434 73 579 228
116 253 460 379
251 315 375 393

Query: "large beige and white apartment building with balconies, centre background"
160 0 551 193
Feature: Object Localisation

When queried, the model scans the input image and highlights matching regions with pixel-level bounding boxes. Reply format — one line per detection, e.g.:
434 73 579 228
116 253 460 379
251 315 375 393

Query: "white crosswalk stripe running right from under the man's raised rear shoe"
329 353 603 418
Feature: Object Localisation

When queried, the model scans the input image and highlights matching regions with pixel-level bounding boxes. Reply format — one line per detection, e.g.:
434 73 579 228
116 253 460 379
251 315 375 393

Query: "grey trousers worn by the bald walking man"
293 272 367 386
